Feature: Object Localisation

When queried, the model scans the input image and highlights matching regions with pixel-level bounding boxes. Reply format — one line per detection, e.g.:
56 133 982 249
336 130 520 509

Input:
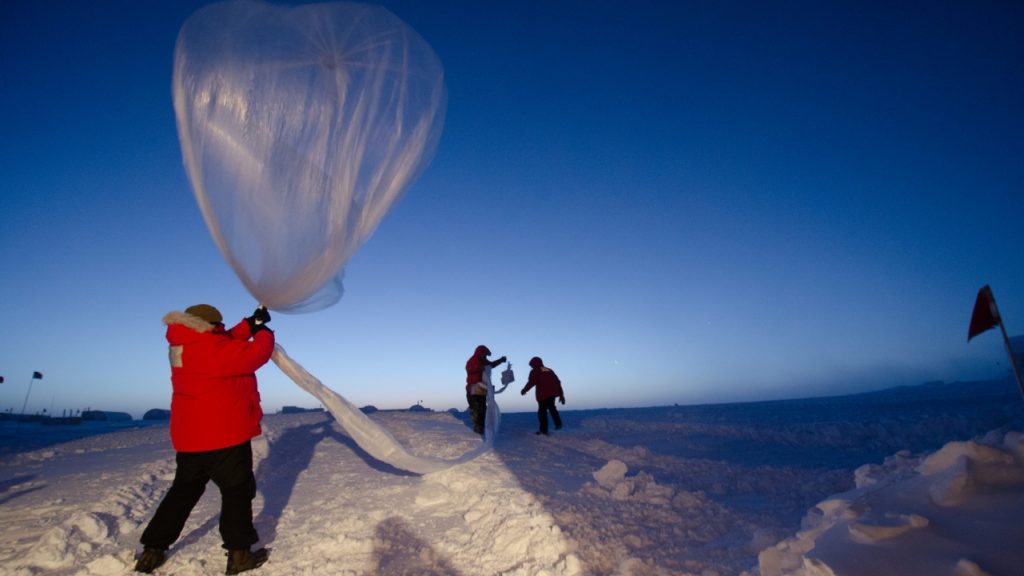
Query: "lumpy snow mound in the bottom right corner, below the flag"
758 431 1024 576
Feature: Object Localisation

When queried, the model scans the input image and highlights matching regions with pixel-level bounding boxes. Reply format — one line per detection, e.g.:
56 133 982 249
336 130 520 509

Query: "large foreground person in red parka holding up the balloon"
135 304 274 574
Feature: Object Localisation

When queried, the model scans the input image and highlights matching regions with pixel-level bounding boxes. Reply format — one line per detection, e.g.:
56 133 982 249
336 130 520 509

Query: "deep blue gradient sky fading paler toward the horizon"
0 0 1024 416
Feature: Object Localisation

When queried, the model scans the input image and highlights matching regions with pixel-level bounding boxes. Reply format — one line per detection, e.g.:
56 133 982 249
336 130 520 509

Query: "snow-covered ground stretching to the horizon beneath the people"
0 380 1024 576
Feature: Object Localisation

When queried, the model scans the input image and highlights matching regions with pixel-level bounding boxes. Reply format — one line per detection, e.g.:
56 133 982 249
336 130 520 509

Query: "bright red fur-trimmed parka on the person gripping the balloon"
164 312 273 452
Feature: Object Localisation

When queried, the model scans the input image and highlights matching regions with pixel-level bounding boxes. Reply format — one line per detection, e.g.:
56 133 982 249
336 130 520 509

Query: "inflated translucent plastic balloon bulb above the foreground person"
173 1 446 313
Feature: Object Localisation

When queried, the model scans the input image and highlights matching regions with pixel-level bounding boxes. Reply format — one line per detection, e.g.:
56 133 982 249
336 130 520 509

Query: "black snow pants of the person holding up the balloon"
141 442 259 550
